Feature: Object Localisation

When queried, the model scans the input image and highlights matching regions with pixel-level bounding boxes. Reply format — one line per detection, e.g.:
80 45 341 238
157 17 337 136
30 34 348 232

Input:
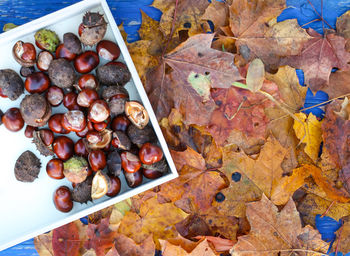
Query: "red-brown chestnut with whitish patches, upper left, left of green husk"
12 41 36 67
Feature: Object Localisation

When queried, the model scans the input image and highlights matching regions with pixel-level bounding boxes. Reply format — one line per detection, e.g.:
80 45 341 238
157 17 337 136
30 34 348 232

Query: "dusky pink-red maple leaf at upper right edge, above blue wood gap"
283 29 350 91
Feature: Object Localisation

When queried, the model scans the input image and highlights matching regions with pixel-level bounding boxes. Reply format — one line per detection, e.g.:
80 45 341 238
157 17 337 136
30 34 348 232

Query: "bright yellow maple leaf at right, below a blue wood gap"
293 112 322 162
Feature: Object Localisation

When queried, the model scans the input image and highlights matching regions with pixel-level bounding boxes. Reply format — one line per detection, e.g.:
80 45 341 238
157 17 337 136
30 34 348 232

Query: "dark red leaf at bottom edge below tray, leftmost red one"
52 222 80 256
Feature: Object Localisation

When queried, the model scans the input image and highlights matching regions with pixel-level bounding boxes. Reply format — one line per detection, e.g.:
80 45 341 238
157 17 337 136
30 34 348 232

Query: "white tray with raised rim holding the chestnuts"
0 0 178 251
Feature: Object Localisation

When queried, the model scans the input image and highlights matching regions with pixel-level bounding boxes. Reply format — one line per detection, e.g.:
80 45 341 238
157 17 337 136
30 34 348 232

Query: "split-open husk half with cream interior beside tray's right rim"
125 101 149 129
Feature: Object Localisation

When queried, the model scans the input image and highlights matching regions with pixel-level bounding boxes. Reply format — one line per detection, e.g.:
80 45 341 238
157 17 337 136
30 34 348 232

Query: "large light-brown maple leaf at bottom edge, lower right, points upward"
230 195 327 256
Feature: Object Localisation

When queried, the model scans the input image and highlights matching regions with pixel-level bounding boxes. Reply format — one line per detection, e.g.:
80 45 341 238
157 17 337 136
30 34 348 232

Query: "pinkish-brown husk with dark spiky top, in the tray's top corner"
80 12 107 46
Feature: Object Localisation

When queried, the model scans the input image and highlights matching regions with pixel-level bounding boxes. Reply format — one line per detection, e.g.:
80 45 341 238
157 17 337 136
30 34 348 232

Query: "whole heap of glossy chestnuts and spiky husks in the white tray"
0 12 168 212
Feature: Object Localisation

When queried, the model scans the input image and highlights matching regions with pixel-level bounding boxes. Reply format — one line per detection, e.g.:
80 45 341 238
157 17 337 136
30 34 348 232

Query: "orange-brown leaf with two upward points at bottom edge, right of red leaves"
115 234 155 256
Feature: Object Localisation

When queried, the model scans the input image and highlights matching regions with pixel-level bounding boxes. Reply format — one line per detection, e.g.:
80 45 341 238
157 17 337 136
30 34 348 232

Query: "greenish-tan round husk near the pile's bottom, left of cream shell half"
63 156 89 183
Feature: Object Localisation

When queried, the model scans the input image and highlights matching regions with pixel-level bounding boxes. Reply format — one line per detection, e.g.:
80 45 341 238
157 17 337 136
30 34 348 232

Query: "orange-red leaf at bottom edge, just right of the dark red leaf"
84 217 116 256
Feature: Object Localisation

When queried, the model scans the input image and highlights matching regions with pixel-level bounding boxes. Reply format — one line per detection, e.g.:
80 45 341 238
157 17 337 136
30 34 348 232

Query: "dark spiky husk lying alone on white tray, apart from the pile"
15 150 41 182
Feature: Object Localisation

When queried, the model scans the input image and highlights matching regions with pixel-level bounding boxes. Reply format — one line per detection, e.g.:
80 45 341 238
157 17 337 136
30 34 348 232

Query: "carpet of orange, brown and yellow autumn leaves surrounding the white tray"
35 0 350 256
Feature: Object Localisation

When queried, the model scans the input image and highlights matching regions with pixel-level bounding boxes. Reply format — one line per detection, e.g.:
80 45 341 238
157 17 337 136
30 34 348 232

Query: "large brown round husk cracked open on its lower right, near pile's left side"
20 93 51 127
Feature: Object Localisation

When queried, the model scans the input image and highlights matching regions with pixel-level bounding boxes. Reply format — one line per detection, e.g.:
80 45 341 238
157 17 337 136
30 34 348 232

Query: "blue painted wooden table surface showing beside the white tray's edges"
0 0 162 256
